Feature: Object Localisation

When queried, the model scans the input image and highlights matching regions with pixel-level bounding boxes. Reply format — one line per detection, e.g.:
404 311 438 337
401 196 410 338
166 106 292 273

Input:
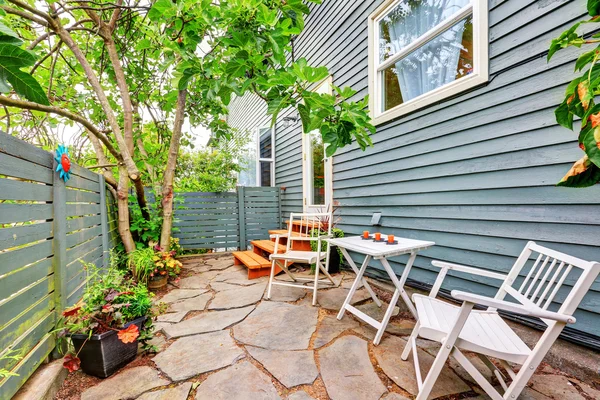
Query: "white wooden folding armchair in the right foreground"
402 242 600 400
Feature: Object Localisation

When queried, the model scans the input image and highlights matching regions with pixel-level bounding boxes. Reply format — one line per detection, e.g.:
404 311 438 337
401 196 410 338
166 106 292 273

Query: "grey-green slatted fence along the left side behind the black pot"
0 133 118 399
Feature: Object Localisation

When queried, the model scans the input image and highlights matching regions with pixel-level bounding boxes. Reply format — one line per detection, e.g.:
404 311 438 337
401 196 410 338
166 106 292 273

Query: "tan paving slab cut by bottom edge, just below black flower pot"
81 366 171 400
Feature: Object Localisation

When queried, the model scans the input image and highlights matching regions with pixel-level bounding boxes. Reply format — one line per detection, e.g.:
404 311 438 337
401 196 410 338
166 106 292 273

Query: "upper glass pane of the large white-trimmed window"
379 0 470 62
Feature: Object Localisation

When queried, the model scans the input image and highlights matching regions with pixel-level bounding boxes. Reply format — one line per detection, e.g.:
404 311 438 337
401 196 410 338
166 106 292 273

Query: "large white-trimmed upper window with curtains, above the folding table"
369 0 488 124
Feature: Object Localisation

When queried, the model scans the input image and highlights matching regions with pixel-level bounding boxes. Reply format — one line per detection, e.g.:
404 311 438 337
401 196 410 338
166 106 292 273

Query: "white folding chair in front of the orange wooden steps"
267 213 335 306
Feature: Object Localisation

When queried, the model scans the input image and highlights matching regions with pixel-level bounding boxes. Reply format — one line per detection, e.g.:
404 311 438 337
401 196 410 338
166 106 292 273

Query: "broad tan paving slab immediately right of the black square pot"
152 330 245 381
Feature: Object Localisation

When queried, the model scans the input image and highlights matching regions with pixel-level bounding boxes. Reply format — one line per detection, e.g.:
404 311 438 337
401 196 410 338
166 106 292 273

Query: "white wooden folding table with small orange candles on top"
328 235 435 345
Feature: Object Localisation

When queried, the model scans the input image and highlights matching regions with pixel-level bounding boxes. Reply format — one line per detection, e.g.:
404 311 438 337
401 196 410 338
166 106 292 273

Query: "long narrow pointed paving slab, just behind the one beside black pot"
162 306 254 339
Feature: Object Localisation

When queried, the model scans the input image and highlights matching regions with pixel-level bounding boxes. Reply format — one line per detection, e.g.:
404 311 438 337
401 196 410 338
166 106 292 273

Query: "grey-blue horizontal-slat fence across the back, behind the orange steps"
173 186 282 250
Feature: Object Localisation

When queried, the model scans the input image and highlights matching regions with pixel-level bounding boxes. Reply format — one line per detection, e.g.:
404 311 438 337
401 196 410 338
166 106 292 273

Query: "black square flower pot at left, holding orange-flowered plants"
71 317 146 378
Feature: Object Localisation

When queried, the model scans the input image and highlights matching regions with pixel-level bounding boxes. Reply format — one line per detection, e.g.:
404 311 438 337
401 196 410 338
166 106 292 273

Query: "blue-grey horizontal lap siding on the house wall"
229 0 600 336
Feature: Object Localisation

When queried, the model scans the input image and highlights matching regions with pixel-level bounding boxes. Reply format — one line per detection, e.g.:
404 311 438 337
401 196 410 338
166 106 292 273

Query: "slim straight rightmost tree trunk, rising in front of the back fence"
160 89 187 250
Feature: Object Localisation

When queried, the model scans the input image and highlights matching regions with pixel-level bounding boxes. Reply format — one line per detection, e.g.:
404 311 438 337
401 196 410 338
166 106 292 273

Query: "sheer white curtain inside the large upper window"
382 0 469 102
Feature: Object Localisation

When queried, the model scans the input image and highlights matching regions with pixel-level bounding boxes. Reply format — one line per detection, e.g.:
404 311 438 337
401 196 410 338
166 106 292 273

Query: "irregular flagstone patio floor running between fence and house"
72 257 600 400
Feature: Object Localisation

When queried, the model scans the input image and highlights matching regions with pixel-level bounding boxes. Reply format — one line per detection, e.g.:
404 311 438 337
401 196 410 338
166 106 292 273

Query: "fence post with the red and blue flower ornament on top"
52 156 69 320
